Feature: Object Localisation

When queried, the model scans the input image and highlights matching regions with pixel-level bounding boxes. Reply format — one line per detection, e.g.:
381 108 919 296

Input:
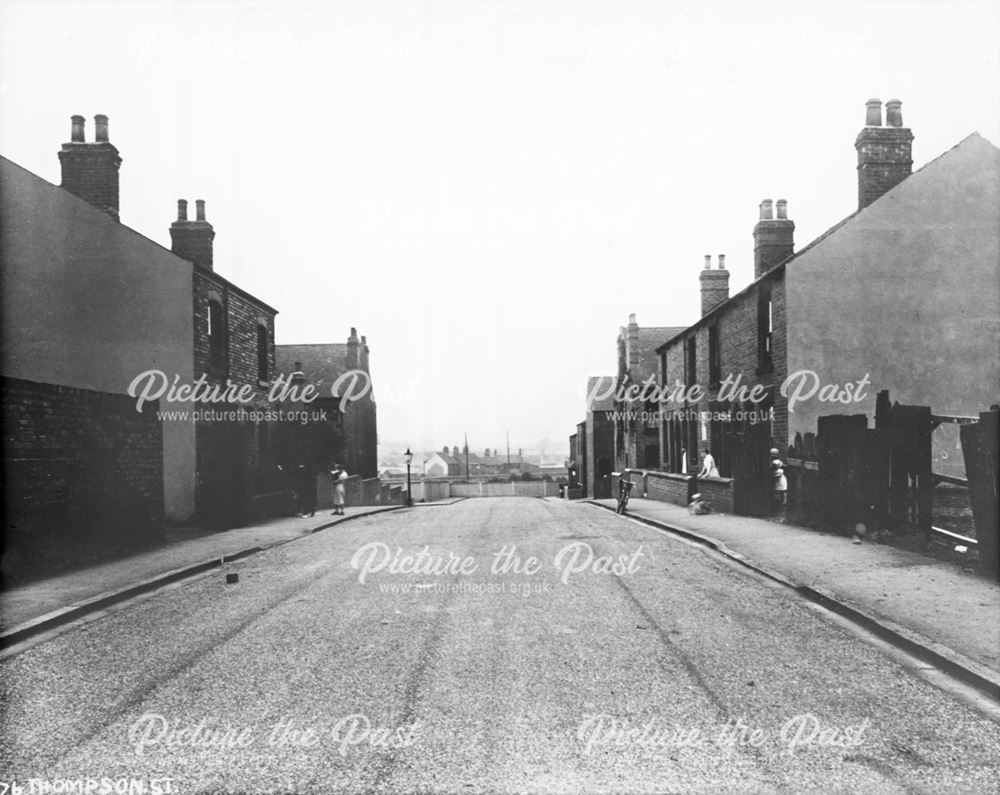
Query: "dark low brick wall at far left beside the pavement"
2 378 163 556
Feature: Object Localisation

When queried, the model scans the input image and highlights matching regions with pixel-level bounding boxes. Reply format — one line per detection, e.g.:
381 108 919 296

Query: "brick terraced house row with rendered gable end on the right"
657 100 1000 486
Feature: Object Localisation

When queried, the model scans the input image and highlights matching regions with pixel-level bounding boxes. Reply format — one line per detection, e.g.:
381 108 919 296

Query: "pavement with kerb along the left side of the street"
0 506 406 646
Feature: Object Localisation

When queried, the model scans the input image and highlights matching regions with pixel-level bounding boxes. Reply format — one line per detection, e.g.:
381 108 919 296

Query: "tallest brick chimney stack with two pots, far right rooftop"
854 99 913 210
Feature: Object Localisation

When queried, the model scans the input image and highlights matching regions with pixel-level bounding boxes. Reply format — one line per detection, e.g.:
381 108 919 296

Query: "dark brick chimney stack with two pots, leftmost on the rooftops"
59 114 122 221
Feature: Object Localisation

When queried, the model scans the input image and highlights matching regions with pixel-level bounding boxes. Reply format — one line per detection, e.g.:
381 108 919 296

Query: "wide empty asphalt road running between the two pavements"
0 498 1000 795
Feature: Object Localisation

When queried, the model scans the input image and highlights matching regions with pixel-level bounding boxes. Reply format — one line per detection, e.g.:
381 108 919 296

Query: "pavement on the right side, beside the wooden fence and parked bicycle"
592 498 1000 692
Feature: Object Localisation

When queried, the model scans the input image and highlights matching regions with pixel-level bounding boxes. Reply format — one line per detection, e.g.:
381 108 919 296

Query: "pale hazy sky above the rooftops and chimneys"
0 0 1000 450
